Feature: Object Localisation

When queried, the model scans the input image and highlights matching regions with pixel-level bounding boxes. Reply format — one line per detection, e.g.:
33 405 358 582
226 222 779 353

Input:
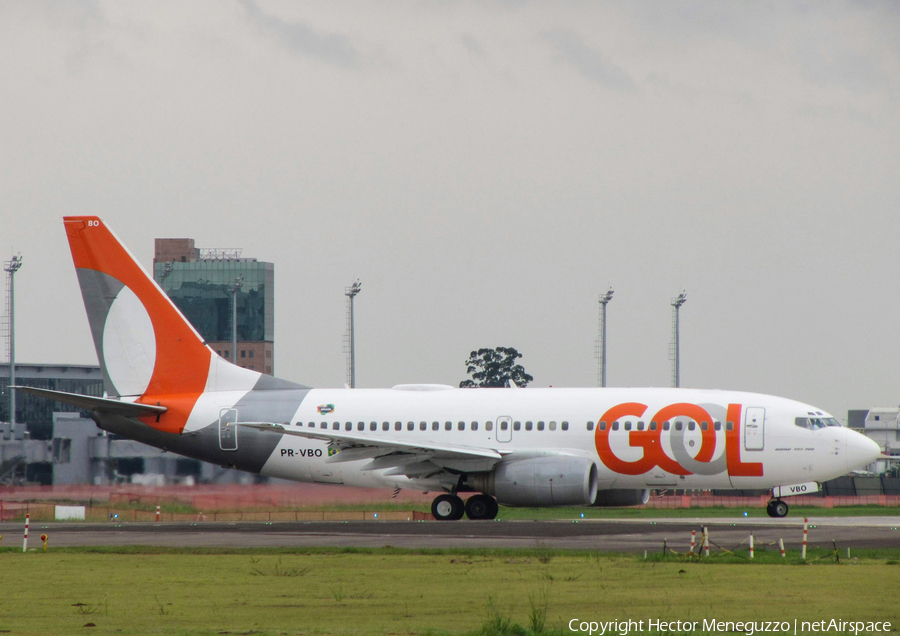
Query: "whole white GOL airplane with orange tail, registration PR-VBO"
19 216 881 520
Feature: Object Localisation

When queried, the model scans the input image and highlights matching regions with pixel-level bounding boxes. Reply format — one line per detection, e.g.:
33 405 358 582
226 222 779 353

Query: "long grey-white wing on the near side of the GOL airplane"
240 422 508 478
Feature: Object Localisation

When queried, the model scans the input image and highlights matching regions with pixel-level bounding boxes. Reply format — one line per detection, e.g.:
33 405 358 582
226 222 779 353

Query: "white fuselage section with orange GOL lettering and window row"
248 387 872 489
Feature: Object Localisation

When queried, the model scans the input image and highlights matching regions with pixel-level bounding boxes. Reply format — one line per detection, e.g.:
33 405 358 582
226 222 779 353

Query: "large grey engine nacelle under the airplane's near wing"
472 457 597 506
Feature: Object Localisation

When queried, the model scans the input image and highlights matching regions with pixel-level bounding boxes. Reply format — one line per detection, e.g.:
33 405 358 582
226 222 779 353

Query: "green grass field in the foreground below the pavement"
0 548 900 635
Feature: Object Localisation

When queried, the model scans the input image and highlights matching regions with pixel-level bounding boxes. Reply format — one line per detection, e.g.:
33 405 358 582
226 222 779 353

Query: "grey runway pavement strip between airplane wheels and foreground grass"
0 516 900 552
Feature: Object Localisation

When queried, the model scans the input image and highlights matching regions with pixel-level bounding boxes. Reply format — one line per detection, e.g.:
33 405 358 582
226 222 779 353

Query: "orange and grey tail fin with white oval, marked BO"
64 216 260 432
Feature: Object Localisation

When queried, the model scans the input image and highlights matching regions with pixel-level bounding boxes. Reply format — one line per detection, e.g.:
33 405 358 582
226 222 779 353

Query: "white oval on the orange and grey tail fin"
103 287 156 396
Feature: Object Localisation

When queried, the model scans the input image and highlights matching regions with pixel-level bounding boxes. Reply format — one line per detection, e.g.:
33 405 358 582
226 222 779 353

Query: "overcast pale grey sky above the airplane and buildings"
0 0 900 418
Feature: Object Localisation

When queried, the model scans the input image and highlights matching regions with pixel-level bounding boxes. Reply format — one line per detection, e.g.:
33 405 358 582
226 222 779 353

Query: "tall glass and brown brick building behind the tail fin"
153 238 275 375
